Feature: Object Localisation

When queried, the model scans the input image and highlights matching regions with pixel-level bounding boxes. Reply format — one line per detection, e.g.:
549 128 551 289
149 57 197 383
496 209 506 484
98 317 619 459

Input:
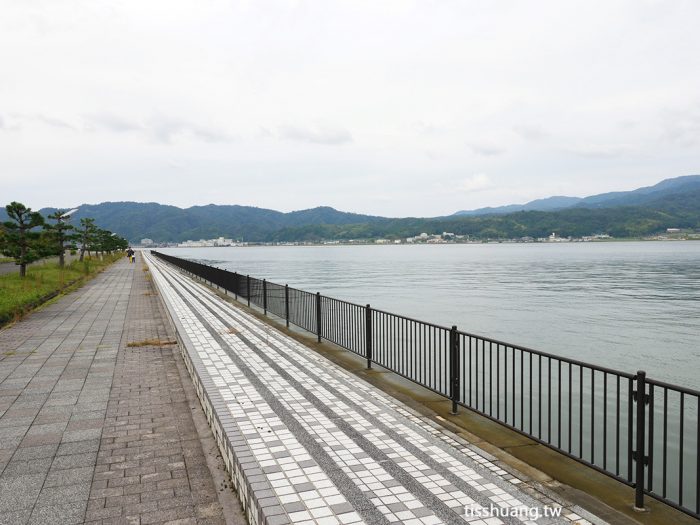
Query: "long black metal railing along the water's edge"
151 251 700 518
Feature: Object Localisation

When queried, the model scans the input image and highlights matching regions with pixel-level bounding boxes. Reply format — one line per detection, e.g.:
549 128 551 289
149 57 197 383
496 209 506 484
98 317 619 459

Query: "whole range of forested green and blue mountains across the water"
0 175 700 243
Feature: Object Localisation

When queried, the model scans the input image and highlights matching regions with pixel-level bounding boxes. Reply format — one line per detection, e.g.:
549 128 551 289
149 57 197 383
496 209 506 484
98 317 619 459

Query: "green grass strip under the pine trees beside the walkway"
0 254 123 326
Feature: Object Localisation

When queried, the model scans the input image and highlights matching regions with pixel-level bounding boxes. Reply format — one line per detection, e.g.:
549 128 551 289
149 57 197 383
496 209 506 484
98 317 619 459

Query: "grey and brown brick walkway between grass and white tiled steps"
0 254 238 525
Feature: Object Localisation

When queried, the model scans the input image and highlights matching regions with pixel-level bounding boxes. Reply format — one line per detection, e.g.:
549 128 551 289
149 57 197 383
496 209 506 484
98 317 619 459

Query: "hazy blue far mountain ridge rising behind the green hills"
455 175 700 215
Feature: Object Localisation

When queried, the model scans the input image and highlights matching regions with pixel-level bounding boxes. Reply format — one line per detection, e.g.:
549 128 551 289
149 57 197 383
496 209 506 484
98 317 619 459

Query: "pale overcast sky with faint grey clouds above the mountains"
0 0 700 216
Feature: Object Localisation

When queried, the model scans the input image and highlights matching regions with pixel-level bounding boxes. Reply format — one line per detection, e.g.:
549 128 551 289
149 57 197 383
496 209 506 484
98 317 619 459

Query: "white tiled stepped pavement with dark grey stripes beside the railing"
147 251 600 525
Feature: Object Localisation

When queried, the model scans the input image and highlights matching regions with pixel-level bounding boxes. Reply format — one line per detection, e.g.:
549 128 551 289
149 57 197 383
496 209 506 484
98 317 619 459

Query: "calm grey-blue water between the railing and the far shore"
163 242 700 389
